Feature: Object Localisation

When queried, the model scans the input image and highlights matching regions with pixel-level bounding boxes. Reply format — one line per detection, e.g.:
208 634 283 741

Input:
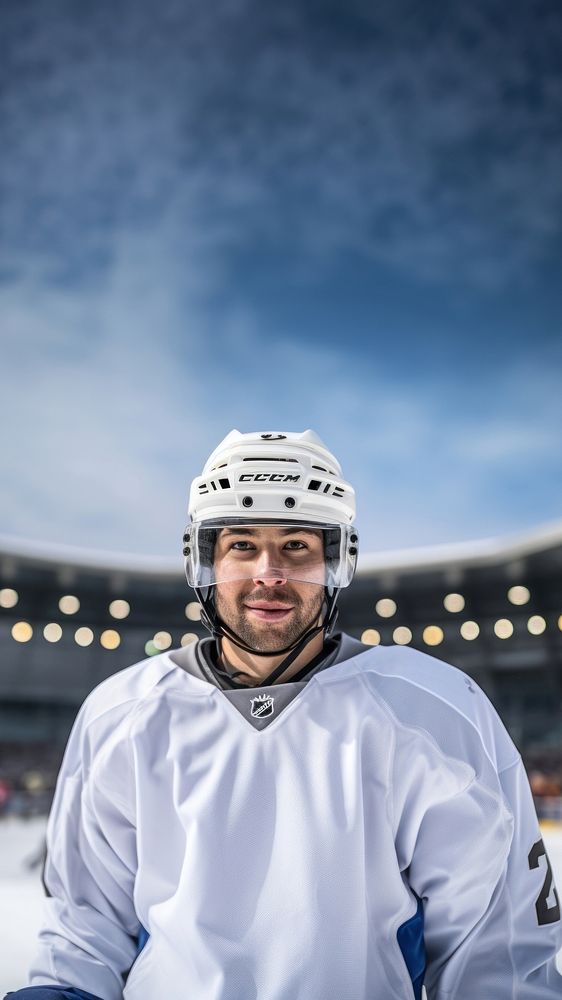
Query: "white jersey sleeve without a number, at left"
29 700 140 1000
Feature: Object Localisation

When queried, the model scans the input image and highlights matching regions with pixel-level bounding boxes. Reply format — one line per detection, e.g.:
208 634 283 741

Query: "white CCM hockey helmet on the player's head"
184 430 358 590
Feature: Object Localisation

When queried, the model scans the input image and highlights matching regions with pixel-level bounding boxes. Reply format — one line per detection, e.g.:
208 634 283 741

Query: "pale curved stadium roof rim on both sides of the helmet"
0 520 562 580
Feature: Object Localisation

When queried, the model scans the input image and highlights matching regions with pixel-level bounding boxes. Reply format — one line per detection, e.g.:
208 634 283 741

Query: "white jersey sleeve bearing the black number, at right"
372 648 562 1000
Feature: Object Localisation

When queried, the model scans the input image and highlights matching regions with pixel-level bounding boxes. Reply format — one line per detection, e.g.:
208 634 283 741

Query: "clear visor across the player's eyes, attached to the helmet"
184 519 357 588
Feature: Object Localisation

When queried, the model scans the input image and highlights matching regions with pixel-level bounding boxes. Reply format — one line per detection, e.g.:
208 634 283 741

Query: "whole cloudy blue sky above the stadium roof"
0 0 562 555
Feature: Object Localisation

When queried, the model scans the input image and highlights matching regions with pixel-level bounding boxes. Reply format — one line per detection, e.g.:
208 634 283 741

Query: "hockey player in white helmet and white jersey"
7 431 562 1000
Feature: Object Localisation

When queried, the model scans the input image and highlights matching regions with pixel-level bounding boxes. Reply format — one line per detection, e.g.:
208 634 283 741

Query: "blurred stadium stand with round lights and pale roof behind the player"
0 521 562 819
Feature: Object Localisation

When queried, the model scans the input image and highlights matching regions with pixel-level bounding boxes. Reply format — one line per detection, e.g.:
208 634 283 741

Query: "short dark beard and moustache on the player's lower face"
215 584 324 653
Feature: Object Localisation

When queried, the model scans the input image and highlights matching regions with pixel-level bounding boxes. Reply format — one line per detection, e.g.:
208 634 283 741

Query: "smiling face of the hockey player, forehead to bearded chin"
214 525 324 653
